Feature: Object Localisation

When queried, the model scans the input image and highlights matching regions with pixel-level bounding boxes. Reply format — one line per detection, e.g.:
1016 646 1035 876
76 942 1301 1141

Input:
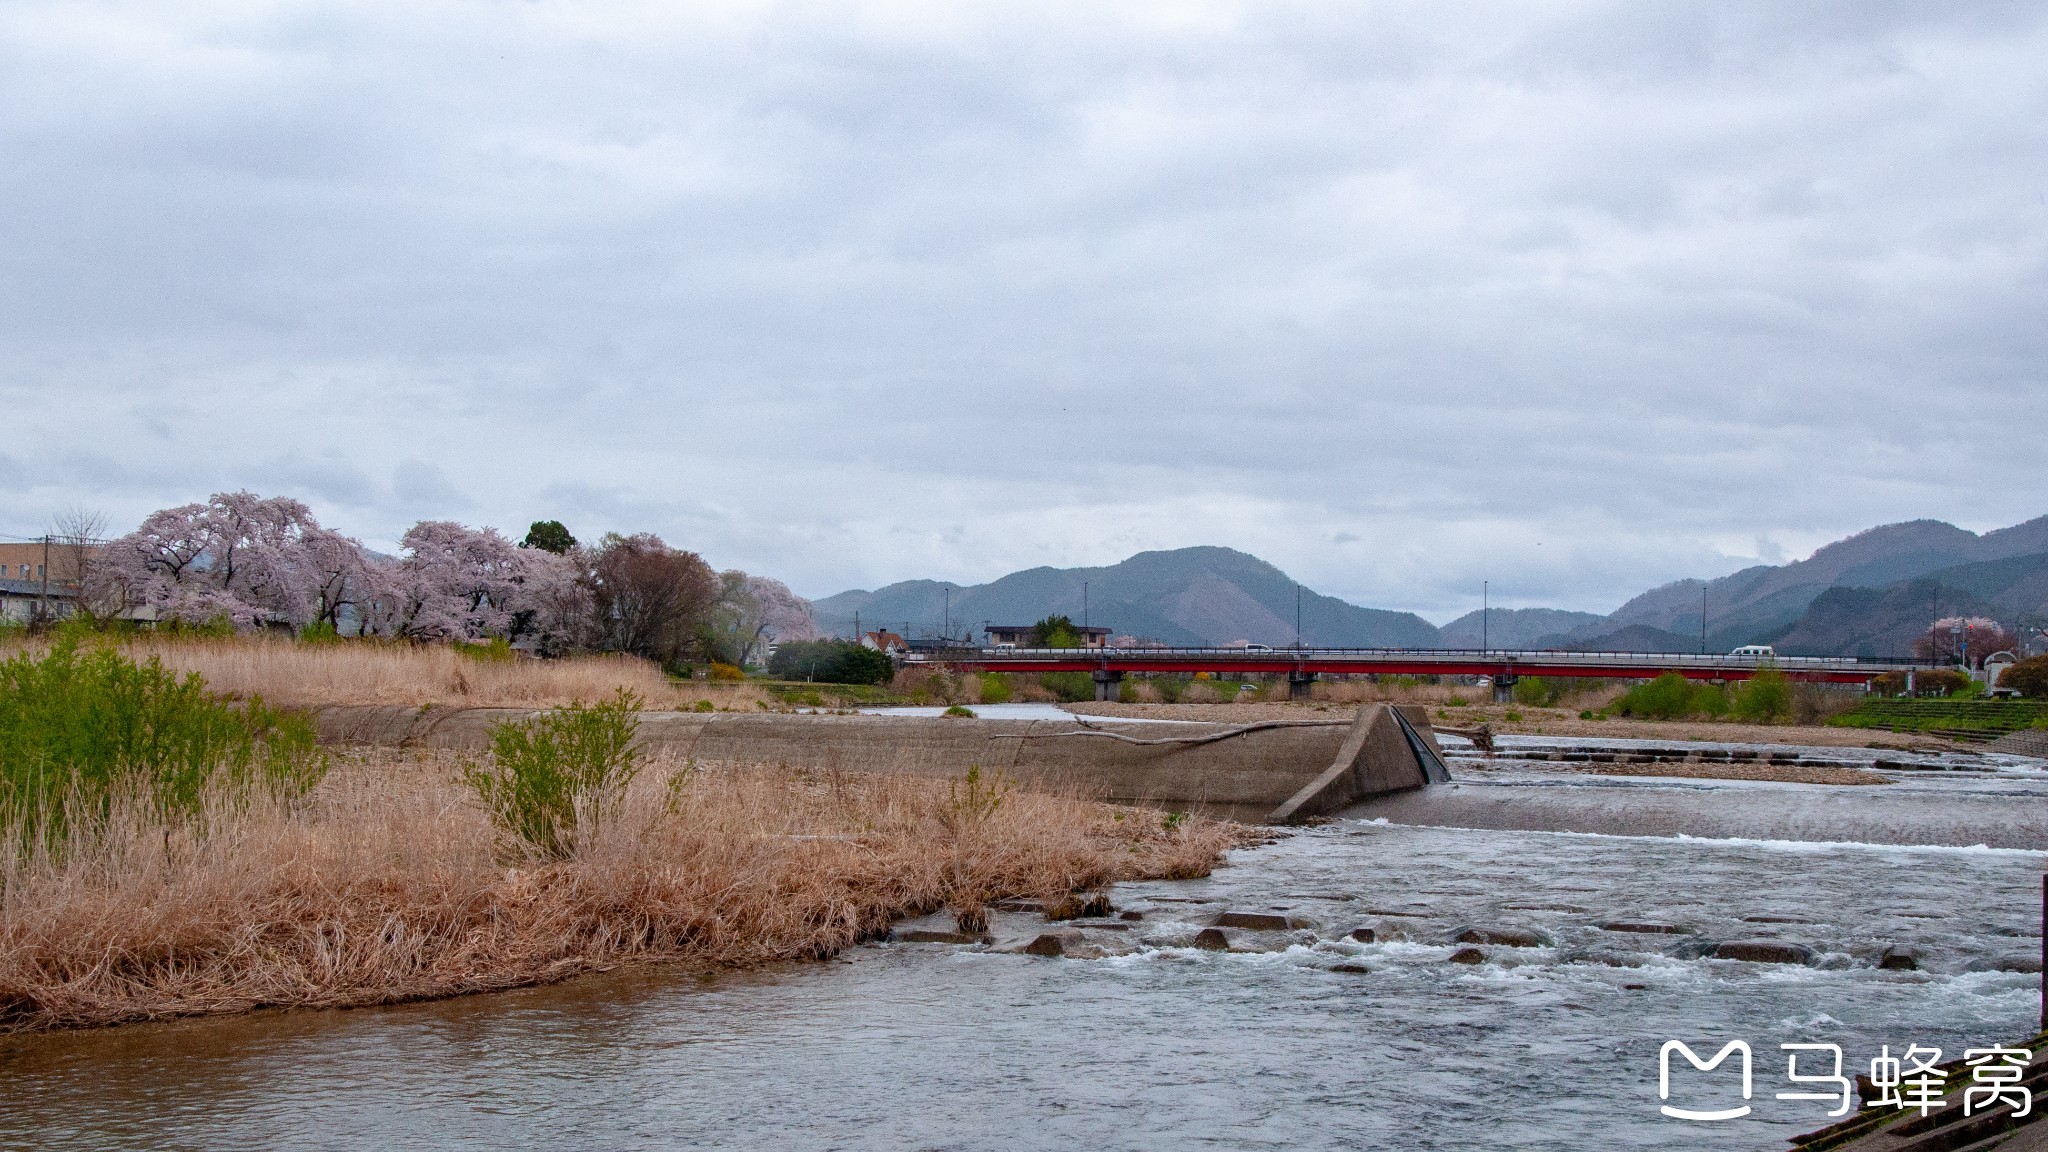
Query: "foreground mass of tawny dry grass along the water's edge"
0 752 1235 1031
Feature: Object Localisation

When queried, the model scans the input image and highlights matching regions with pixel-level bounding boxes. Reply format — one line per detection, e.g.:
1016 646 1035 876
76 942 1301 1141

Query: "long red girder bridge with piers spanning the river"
905 648 1935 699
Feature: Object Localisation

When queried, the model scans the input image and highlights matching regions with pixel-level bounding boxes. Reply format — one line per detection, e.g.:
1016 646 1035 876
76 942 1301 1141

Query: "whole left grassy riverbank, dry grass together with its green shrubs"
0 642 1239 1031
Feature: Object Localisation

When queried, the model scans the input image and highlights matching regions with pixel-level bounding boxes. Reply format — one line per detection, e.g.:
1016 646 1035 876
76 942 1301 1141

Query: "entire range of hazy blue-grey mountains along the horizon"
813 517 2048 656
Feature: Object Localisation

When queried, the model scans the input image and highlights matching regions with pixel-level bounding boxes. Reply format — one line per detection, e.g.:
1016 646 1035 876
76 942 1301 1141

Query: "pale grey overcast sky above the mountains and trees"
0 0 2048 621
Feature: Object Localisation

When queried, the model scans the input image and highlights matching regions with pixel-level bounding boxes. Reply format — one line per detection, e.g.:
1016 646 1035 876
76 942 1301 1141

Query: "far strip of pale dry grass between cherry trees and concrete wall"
0 635 766 711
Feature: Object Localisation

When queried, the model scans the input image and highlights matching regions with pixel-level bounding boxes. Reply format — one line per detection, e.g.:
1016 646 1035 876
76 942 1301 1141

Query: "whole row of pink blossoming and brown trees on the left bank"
80 492 817 668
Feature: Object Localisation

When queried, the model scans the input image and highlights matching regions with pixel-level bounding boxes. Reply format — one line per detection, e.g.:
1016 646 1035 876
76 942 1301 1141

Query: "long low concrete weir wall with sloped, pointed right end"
315 703 1450 824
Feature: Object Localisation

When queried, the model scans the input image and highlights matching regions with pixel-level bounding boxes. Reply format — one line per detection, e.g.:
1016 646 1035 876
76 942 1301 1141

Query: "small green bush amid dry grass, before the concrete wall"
463 689 641 859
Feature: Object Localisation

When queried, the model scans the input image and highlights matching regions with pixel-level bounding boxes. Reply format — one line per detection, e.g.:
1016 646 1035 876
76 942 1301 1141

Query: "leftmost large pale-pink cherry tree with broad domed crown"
86 492 369 627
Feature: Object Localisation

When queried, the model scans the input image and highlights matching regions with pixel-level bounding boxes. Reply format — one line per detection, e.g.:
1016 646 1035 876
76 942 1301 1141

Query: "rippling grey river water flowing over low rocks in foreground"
0 737 2044 1152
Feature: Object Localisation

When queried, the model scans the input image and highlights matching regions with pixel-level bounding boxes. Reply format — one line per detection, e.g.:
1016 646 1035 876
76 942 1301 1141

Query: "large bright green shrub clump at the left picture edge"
0 637 328 840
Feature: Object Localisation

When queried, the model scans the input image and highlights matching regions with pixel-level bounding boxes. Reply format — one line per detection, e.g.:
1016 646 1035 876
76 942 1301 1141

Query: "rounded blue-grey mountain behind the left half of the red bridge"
811 547 1438 648
